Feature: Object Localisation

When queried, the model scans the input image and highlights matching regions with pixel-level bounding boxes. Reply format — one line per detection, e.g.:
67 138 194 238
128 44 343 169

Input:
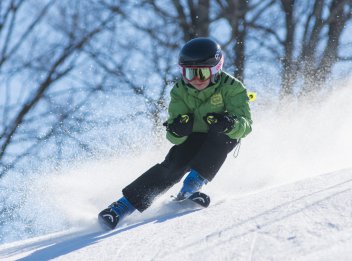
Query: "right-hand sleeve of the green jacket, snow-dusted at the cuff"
225 81 252 139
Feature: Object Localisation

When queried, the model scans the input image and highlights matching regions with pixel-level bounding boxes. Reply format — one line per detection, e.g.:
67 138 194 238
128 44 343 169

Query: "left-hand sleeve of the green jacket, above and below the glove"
166 85 190 145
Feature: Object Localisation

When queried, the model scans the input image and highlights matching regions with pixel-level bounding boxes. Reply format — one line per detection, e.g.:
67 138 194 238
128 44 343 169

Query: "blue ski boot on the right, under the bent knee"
176 169 208 201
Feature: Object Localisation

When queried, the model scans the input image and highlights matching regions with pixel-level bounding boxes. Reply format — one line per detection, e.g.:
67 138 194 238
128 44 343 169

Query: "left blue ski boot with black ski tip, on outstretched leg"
98 197 136 229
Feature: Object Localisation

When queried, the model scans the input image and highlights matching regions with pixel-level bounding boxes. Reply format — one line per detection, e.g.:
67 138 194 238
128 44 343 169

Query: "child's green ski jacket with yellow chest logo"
166 72 252 145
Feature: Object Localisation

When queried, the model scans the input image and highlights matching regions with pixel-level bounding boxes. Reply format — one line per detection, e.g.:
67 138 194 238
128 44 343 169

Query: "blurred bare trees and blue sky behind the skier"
0 0 352 176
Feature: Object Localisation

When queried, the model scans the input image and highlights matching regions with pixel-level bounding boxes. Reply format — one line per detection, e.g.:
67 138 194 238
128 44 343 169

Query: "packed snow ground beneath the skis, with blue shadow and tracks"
0 170 352 260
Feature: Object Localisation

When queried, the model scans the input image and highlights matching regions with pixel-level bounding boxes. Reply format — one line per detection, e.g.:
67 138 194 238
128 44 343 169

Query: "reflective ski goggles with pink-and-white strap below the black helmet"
179 57 224 81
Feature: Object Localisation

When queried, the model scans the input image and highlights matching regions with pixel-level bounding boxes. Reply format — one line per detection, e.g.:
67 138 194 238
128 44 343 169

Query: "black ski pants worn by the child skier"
122 132 238 212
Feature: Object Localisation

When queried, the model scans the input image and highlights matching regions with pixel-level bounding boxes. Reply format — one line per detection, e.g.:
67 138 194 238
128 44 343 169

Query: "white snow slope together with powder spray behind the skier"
0 80 352 260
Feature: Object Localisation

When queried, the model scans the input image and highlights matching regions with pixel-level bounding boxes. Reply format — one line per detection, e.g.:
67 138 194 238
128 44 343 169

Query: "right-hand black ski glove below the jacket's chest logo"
203 113 235 133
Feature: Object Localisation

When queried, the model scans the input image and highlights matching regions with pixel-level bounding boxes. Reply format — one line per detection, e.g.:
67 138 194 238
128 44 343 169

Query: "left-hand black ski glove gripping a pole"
163 113 193 137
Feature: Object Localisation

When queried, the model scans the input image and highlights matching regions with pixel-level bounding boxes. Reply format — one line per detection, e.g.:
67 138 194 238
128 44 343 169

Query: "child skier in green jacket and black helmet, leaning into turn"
99 38 252 229
